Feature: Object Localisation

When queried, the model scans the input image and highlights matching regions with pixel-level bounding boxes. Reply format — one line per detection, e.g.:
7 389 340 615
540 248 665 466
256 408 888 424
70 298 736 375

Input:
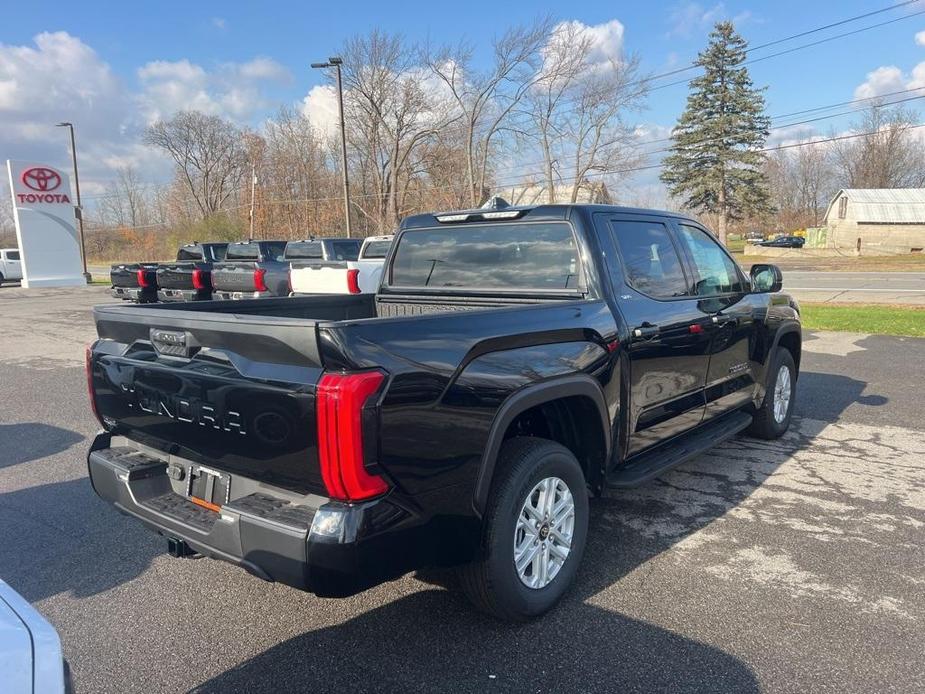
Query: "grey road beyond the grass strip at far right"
784 270 925 305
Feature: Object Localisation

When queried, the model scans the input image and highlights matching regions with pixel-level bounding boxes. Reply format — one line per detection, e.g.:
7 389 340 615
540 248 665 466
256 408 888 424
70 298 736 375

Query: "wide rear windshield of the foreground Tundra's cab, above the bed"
390 222 581 293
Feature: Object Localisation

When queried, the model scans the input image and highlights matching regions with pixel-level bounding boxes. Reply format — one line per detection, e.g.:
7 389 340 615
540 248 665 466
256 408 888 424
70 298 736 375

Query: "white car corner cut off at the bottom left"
0 580 67 694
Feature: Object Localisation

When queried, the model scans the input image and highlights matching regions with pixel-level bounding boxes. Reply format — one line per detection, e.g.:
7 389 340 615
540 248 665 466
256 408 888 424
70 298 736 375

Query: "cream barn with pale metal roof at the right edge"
825 188 925 253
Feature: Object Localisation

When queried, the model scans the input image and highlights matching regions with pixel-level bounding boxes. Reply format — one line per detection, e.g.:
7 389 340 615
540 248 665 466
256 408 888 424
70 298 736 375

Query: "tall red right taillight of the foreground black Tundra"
315 371 389 501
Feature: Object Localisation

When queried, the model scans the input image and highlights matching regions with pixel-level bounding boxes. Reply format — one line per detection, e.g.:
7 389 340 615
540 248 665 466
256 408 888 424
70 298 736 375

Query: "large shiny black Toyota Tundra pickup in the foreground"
87 205 801 620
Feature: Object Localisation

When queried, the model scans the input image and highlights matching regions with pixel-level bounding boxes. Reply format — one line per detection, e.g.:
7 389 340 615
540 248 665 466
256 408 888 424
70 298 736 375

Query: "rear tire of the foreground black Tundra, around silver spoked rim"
458 437 589 622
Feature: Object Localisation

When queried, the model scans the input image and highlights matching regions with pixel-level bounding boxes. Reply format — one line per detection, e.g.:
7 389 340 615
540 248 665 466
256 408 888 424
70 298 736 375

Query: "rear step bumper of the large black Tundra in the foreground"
87 432 414 597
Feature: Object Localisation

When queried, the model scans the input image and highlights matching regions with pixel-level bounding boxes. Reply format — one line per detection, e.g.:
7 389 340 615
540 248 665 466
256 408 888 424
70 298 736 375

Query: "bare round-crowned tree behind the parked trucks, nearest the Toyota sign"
144 111 249 217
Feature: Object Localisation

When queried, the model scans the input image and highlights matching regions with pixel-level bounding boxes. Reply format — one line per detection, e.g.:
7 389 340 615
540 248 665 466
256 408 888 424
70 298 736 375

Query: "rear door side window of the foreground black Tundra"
612 221 689 299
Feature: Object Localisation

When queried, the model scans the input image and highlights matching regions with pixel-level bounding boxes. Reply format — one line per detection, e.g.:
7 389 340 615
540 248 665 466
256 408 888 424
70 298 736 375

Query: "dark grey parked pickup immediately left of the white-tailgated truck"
212 241 289 301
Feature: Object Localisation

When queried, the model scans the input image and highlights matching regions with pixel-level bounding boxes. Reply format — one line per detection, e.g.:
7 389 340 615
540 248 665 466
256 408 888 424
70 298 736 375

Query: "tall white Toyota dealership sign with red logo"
6 160 86 287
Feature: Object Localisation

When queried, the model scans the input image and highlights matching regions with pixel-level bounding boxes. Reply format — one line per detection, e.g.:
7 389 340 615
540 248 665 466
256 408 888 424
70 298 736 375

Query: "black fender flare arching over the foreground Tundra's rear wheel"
473 374 611 516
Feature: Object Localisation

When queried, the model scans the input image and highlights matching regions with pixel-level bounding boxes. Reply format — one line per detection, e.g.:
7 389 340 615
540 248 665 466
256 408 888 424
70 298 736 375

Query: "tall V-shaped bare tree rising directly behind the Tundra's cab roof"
425 19 551 207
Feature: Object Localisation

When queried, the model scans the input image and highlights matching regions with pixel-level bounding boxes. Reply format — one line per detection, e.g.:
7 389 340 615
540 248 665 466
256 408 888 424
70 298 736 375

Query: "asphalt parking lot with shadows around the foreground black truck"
0 287 925 692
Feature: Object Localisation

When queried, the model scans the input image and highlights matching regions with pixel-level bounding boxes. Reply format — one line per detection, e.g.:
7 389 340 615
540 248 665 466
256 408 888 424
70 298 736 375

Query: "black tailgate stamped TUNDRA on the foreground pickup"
90 306 324 493
